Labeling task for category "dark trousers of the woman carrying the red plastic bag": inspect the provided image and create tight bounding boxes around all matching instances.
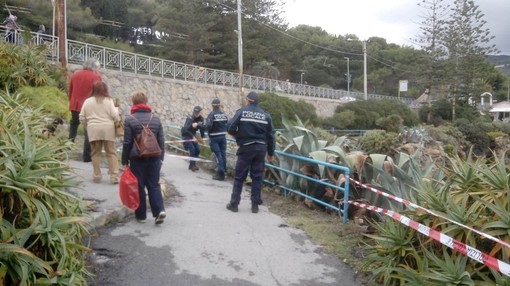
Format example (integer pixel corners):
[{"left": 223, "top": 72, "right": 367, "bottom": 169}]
[{"left": 129, "top": 158, "right": 165, "bottom": 219}]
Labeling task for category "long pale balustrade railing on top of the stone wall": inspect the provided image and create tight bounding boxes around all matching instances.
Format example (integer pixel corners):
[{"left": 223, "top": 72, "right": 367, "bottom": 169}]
[{"left": 0, "top": 26, "right": 414, "bottom": 104}]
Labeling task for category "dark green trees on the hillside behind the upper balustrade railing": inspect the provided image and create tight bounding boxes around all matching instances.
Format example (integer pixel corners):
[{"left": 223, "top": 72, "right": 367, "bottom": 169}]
[{"left": 0, "top": 0, "right": 508, "bottom": 99}]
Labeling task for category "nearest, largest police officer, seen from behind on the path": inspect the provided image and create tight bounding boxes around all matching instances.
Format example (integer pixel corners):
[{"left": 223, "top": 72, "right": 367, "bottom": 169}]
[{"left": 227, "top": 91, "right": 275, "bottom": 213}]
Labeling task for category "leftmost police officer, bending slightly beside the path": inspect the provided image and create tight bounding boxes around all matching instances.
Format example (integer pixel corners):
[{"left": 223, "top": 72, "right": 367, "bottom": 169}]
[{"left": 181, "top": 105, "right": 205, "bottom": 172}]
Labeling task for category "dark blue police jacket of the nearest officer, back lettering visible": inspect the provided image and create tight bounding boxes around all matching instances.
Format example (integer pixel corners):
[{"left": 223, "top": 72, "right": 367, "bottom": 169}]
[{"left": 227, "top": 104, "right": 275, "bottom": 156}]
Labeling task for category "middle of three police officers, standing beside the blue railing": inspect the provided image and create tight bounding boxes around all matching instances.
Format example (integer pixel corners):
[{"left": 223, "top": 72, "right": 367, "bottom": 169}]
[{"left": 205, "top": 98, "right": 228, "bottom": 181}]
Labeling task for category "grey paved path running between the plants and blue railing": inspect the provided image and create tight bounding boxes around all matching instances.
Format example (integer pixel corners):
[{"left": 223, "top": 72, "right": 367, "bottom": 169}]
[{"left": 71, "top": 153, "right": 359, "bottom": 286}]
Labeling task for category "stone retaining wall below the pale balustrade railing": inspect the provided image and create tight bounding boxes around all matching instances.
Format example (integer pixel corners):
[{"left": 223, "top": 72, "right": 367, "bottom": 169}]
[{"left": 70, "top": 65, "right": 341, "bottom": 126}]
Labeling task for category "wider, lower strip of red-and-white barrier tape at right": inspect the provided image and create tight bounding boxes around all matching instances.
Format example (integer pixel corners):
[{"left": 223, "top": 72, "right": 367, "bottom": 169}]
[{"left": 348, "top": 201, "right": 510, "bottom": 277}]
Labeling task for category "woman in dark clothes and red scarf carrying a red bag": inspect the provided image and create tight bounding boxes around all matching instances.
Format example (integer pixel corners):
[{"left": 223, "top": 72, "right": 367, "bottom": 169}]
[{"left": 122, "top": 91, "right": 166, "bottom": 224}]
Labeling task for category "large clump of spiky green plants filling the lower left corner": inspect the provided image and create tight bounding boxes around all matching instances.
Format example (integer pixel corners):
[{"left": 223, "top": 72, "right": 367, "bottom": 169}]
[{"left": 0, "top": 93, "right": 90, "bottom": 285}]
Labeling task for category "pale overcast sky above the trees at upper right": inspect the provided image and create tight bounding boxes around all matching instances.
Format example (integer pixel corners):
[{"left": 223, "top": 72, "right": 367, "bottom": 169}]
[{"left": 284, "top": 0, "right": 510, "bottom": 55}]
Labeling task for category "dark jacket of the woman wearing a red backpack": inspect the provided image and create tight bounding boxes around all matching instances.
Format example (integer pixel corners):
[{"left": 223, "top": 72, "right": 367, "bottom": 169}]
[{"left": 122, "top": 109, "right": 165, "bottom": 165}]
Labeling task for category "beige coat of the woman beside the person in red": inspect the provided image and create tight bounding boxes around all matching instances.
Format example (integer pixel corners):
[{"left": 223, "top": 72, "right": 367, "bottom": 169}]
[{"left": 80, "top": 96, "right": 120, "bottom": 142}]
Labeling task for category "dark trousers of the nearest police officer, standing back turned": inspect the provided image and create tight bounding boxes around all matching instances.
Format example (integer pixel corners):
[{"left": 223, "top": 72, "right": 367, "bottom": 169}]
[{"left": 230, "top": 150, "right": 266, "bottom": 206}]
